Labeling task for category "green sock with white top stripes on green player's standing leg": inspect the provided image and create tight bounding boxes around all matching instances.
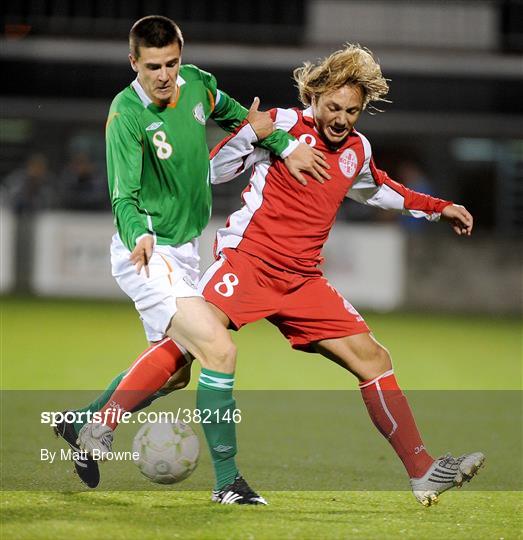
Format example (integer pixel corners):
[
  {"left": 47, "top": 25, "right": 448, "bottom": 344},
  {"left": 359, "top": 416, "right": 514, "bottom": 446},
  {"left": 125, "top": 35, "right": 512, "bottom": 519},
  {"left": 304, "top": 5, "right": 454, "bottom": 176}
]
[{"left": 196, "top": 368, "right": 238, "bottom": 490}]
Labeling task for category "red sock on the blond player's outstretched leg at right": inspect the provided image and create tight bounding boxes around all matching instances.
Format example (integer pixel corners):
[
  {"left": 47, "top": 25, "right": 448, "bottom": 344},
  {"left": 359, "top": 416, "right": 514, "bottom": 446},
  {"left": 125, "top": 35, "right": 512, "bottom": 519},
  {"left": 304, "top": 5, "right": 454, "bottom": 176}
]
[{"left": 360, "top": 370, "right": 434, "bottom": 478}]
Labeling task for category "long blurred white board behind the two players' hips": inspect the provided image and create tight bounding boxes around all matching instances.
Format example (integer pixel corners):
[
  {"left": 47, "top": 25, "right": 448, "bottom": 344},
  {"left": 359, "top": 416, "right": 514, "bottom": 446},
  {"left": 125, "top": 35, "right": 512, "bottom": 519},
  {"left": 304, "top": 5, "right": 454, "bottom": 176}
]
[{"left": 27, "top": 212, "right": 405, "bottom": 310}]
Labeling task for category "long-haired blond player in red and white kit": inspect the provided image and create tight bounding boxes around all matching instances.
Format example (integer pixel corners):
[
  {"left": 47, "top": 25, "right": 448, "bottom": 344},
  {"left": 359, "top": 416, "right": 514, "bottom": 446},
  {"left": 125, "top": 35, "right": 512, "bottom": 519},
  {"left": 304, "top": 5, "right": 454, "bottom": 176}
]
[{"left": 71, "top": 45, "right": 484, "bottom": 506}]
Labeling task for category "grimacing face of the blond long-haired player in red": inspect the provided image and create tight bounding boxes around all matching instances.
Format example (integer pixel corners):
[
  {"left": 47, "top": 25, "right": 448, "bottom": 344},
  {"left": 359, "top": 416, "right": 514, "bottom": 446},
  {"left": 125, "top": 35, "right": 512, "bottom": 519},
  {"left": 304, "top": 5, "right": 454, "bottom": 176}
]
[{"left": 312, "top": 85, "right": 363, "bottom": 147}]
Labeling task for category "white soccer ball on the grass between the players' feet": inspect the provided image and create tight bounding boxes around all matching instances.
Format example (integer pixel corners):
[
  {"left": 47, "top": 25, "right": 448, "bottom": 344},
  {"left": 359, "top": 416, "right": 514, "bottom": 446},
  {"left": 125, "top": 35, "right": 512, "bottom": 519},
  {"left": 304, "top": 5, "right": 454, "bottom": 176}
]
[{"left": 133, "top": 422, "right": 200, "bottom": 484}]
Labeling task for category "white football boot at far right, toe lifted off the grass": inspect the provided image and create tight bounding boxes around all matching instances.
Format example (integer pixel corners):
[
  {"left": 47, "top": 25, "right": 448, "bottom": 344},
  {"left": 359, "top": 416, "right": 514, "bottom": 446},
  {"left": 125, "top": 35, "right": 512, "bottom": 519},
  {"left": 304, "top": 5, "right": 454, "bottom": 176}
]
[{"left": 410, "top": 452, "right": 485, "bottom": 506}]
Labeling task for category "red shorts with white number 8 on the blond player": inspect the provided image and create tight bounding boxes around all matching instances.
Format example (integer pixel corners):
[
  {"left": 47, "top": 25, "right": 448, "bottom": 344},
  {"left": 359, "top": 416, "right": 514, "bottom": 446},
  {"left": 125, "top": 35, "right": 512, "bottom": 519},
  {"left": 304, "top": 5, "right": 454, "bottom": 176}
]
[{"left": 200, "top": 249, "right": 370, "bottom": 352}]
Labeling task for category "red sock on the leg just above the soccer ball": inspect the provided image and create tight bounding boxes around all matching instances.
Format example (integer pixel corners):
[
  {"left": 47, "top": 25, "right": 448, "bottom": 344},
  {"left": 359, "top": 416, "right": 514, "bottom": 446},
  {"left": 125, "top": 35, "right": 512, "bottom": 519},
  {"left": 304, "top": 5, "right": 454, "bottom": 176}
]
[{"left": 100, "top": 338, "right": 187, "bottom": 429}]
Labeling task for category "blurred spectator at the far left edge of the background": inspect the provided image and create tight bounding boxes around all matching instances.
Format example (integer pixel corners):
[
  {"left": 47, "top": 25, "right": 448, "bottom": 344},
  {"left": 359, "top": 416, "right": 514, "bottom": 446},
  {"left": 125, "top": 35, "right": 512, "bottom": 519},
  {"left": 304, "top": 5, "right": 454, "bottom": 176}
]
[{"left": 2, "top": 153, "right": 57, "bottom": 214}]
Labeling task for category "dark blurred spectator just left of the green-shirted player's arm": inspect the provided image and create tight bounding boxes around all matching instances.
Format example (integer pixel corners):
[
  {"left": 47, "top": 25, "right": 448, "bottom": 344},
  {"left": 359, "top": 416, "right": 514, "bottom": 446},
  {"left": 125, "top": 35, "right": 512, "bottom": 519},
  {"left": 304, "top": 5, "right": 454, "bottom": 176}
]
[{"left": 60, "top": 152, "right": 109, "bottom": 210}]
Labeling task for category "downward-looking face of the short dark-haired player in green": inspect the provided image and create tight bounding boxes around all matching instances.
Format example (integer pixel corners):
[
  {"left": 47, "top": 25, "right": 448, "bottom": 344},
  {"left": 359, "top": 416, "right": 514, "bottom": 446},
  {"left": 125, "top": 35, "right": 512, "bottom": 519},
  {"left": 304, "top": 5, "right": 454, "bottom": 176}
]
[{"left": 129, "top": 42, "right": 181, "bottom": 105}]
